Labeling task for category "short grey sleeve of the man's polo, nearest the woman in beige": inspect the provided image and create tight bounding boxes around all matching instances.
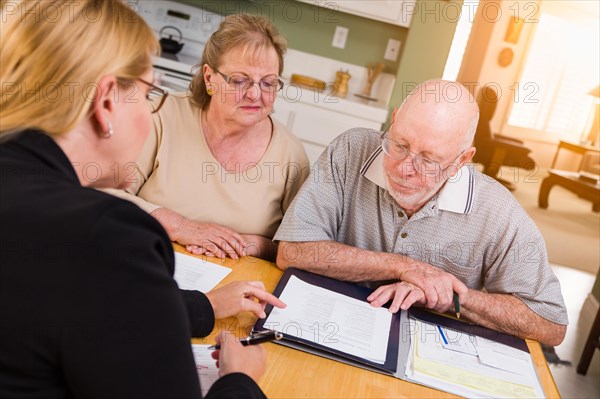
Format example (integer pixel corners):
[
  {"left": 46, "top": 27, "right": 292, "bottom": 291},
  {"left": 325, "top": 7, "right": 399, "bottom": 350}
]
[{"left": 274, "top": 134, "right": 349, "bottom": 242}]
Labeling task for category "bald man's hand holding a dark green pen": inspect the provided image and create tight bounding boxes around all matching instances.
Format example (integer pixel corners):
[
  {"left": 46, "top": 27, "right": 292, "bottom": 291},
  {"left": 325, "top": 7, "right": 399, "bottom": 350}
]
[{"left": 400, "top": 259, "right": 469, "bottom": 313}]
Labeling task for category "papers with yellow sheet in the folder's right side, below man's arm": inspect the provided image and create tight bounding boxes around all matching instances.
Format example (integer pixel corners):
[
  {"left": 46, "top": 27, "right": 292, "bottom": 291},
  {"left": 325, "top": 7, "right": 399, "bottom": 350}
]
[{"left": 405, "top": 319, "right": 545, "bottom": 399}]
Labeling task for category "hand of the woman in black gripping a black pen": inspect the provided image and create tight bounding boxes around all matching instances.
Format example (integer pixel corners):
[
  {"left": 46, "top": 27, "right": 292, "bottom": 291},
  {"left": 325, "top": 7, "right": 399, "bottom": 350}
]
[{"left": 211, "top": 331, "right": 266, "bottom": 382}]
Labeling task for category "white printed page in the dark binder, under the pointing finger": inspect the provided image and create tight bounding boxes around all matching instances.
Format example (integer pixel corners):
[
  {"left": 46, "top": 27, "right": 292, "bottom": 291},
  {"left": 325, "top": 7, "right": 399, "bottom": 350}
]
[{"left": 264, "top": 276, "right": 392, "bottom": 364}]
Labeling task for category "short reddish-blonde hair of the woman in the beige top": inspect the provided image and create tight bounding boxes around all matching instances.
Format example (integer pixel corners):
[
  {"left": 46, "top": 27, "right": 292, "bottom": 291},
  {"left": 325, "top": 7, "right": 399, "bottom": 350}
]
[{"left": 190, "top": 14, "right": 287, "bottom": 109}]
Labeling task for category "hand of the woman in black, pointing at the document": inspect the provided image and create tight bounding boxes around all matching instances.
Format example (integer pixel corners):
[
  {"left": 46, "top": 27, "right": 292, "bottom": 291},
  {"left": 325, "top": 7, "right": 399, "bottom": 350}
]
[{"left": 206, "top": 281, "right": 286, "bottom": 319}]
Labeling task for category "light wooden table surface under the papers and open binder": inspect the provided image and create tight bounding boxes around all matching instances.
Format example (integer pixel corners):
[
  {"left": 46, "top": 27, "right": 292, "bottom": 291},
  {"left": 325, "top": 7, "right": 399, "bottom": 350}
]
[{"left": 174, "top": 244, "right": 560, "bottom": 399}]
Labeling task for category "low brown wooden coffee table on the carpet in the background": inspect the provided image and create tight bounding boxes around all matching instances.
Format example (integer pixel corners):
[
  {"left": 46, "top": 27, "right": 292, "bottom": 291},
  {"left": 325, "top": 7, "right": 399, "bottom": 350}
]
[{"left": 538, "top": 169, "right": 600, "bottom": 212}]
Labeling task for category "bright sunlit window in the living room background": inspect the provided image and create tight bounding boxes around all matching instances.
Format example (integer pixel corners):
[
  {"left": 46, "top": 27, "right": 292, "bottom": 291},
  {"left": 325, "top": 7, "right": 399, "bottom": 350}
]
[{"left": 507, "top": 2, "right": 600, "bottom": 141}]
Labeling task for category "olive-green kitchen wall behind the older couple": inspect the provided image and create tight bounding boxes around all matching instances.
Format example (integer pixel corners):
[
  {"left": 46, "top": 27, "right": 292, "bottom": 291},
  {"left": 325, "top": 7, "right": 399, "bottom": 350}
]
[{"left": 172, "top": 0, "right": 463, "bottom": 119}]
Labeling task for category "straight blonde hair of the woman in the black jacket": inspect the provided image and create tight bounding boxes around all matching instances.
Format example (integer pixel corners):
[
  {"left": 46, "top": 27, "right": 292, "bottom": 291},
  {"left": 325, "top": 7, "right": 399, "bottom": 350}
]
[{"left": 0, "top": 0, "right": 159, "bottom": 138}]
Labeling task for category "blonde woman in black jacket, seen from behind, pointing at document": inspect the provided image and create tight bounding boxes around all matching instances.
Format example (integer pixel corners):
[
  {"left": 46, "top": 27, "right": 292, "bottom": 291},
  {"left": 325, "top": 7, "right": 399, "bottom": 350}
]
[{"left": 0, "top": 0, "right": 282, "bottom": 399}]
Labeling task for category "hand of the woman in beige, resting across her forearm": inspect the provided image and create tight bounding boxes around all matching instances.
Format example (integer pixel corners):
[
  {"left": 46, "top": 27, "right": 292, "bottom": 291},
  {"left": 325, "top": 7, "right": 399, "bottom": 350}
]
[{"left": 171, "top": 219, "right": 248, "bottom": 259}]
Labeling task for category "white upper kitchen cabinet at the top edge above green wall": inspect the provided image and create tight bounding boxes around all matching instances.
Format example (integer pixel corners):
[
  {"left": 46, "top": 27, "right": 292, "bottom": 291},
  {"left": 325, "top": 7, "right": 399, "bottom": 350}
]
[{"left": 298, "top": 0, "right": 416, "bottom": 28}]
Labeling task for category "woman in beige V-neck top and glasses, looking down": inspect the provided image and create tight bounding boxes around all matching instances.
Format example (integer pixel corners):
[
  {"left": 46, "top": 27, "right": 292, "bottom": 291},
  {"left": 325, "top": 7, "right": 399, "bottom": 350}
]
[{"left": 110, "top": 15, "right": 308, "bottom": 259}]
